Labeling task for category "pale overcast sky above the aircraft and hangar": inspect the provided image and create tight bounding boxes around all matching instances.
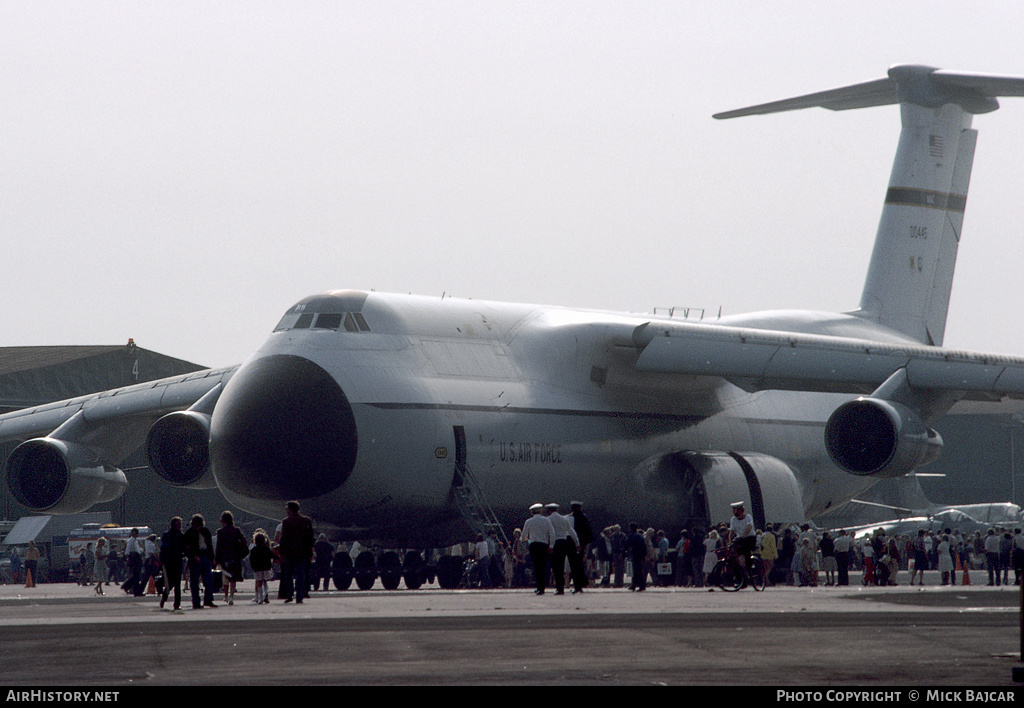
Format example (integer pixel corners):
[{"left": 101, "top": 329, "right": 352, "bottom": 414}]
[{"left": 0, "top": 0, "right": 1024, "bottom": 366}]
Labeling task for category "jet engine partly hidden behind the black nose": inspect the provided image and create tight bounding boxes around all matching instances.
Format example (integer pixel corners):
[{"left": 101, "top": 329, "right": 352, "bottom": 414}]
[{"left": 145, "top": 411, "right": 217, "bottom": 489}]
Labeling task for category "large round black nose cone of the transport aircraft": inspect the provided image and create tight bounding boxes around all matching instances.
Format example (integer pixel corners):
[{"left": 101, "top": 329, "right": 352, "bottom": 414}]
[{"left": 210, "top": 355, "right": 356, "bottom": 500}]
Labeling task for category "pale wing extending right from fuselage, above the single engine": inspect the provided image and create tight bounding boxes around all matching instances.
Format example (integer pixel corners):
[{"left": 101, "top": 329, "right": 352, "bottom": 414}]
[{"left": 633, "top": 323, "right": 1024, "bottom": 401}]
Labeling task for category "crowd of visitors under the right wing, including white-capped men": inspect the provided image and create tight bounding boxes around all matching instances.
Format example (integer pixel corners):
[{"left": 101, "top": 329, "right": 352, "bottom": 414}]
[{"left": 482, "top": 502, "right": 1024, "bottom": 593}]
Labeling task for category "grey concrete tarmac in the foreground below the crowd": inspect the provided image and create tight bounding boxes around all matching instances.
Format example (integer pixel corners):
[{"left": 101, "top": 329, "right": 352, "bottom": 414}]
[{"left": 0, "top": 574, "right": 1021, "bottom": 691}]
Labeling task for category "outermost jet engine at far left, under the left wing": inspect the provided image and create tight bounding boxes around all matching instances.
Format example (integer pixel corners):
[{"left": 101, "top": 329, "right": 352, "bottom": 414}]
[{"left": 7, "top": 438, "right": 128, "bottom": 513}]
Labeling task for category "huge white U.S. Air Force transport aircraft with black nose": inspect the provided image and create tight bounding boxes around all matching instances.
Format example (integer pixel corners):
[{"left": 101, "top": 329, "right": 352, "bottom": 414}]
[{"left": 0, "top": 66, "right": 1024, "bottom": 586}]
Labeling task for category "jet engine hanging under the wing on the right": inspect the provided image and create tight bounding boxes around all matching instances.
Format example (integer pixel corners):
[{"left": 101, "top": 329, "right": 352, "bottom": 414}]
[{"left": 825, "top": 398, "right": 942, "bottom": 477}]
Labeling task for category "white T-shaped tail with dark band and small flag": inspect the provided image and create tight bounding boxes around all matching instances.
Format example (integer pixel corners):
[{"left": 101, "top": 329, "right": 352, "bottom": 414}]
[{"left": 715, "top": 65, "right": 1024, "bottom": 345}]
